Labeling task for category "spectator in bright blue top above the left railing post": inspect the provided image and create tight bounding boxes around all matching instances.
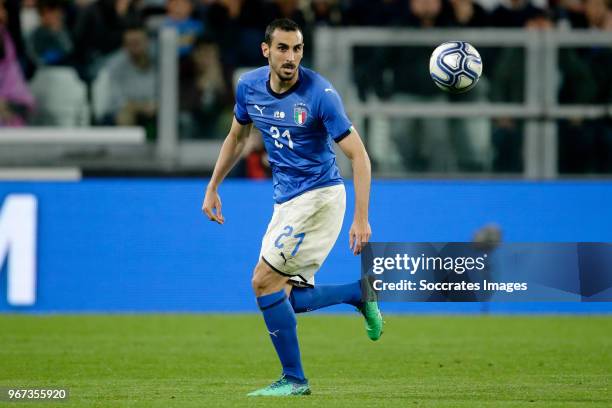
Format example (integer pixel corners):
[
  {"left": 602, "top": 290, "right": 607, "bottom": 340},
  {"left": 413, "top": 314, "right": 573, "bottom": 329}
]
[{"left": 162, "top": 0, "right": 204, "bottom": 58}]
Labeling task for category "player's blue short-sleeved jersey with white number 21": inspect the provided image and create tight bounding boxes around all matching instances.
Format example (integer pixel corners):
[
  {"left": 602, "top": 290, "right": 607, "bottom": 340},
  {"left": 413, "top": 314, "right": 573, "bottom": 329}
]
[{"left": 234, "top": 66, "right": 351, "bottom": 203}]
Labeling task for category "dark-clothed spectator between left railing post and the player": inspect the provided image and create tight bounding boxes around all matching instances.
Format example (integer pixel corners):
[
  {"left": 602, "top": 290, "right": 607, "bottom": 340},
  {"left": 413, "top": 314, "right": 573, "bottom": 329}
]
[{"left": 180, "top": 39, "right": 231, "bottom": 139}]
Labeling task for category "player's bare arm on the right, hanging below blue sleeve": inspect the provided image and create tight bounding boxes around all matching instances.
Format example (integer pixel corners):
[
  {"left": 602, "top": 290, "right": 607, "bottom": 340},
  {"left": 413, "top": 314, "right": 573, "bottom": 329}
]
[{"left": 338, "top": 128, "right": 372, "bottom": 255}]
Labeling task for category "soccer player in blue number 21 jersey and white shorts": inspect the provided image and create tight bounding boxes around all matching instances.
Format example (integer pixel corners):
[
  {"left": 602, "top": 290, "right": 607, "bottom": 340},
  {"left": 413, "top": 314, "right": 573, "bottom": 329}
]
[{"left": 202, "top": 19, "right": 383, "bottom": 396}]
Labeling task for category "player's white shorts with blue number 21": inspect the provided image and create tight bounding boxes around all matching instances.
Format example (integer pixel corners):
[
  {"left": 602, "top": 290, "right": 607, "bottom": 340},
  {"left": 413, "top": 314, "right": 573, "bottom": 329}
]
[{"left": 259, "top": 184, "right": 346, "bottom": 286}]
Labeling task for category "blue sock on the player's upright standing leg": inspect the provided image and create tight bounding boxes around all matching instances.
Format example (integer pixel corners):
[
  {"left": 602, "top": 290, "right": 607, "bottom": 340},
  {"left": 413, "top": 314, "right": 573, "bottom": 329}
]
[{"left": 257, "top": 290, "right": 305, "bottom": 381}]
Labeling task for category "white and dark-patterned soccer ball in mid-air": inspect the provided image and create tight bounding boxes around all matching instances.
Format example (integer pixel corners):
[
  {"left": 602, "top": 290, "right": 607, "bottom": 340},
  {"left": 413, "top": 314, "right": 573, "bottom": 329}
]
[{"left": 429, "top": 41, "right": 482, "bottom": 93}]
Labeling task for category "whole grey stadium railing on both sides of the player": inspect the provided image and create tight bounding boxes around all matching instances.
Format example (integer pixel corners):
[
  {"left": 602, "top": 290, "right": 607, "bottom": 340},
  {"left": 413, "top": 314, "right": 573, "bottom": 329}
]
[{"left": 0, "top": 27, "right": 612, "bottom": 179}]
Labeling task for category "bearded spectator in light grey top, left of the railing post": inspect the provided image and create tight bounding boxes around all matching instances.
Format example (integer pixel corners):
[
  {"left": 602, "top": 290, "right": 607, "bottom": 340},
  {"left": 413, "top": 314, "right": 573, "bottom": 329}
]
[{"left": 109, "top": 25, "right": 157, "bottom": 140}]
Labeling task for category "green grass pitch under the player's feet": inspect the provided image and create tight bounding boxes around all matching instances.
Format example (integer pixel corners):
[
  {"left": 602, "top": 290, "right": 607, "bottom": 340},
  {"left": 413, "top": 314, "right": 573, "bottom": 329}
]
[{"left": 0, "top": 315, "right": 612, "bottom": 408}]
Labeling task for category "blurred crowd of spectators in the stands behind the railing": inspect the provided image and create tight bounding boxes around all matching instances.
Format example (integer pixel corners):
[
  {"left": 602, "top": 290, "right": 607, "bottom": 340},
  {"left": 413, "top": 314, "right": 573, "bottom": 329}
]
[{"left": 0, "top": 0, "right": 612, "bottom": 174}]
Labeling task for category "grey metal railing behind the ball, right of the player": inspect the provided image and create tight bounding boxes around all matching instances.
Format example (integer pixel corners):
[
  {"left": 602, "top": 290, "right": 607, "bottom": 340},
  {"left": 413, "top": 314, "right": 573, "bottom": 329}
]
[{"left": 314, "top": 27, "right": 612, "bottom": 179}]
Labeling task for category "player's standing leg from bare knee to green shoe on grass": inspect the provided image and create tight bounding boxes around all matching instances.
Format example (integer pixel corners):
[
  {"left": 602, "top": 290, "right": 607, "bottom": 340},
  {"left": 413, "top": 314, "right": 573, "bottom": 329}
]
[{"left": 248, "top": 260, "right": 310, "bottom": 396}]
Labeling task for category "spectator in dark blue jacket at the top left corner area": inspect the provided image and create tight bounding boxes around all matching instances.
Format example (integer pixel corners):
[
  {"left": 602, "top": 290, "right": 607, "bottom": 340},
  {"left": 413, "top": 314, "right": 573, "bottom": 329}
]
[{"left": 28, "top": 0, "right": 72, "bottom": 66}]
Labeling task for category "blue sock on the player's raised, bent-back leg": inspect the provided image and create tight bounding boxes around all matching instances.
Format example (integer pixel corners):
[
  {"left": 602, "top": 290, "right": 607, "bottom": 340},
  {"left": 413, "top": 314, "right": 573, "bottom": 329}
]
[{"left": 289, "top": 281, "right": 361, "bottom": 313}]
